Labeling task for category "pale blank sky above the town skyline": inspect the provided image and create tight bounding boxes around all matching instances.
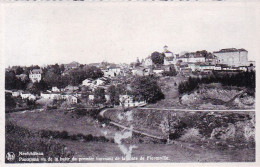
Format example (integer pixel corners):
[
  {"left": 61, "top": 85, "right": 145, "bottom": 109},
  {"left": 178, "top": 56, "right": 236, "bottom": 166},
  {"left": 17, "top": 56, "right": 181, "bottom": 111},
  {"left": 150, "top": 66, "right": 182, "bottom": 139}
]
[{"left": 2, "top": 2, "right": 260, "bottom": 67}]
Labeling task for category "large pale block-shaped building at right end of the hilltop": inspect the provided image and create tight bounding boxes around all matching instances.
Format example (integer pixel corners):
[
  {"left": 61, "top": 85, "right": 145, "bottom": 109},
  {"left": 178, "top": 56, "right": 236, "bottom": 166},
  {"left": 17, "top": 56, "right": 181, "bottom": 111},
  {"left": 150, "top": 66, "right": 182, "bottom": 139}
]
[{"left": 213, "top": 48, "right": 250, "bottom": 67}]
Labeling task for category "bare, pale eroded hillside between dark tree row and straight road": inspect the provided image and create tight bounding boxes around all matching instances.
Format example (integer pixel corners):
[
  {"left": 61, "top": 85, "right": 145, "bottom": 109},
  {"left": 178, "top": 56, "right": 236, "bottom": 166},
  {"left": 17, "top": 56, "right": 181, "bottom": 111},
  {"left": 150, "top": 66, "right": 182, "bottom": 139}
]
[{"left": 147, "top": 75, "right": 255, "bottom": 110}]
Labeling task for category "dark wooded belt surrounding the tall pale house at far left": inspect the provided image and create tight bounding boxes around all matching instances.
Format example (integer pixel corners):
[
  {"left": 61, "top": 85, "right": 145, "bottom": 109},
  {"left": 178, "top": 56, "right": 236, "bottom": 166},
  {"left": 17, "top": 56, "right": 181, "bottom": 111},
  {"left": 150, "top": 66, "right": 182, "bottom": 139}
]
[{"left": 5, "top": 64, "right": 104, "bottom": 94}]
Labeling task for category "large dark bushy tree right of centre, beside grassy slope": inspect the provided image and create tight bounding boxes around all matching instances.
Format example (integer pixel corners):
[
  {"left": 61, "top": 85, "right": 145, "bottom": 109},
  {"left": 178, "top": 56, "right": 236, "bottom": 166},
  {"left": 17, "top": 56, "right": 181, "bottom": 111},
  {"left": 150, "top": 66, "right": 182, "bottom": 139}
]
[{"left": 131, "top": 76, "right": 164, "bottom": 103}]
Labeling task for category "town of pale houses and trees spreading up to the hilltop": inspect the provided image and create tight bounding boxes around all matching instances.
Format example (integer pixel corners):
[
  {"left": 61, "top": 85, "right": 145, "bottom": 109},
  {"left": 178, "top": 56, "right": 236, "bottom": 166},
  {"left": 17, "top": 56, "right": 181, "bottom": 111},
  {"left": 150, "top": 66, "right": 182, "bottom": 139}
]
[{"left": 6, "top": 46, "right": 255, "bottom": 109}]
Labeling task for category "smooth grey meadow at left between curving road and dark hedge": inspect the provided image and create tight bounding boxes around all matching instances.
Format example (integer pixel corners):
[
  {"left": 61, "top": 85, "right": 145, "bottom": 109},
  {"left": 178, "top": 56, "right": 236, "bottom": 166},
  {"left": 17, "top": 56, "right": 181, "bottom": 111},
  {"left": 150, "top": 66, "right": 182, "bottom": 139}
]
[{"left": 6, "top": 110, "right": 118, "bottom": 138}]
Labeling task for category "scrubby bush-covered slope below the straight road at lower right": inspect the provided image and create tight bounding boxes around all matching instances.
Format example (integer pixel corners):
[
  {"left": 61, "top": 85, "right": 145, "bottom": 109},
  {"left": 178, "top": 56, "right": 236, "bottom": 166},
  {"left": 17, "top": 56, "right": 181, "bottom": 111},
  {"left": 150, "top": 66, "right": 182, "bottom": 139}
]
[{"left": 169, "top": 112, "right": 255, "bottom": 144}]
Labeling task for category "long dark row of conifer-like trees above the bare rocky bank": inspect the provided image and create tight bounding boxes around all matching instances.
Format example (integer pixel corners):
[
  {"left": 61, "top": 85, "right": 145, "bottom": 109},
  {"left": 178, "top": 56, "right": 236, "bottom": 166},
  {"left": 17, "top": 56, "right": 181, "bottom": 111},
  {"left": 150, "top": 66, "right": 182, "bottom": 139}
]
[{"left": 178, "top": 71, "right": 256, "bottom": 94}]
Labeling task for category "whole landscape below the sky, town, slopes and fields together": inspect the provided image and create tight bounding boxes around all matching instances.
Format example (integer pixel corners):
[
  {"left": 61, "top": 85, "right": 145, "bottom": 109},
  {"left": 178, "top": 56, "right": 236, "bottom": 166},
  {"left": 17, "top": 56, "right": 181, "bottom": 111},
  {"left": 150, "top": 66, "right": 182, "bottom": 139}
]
[{"left": 5, "top": 46, "right": 255, "bottom": 162}]
